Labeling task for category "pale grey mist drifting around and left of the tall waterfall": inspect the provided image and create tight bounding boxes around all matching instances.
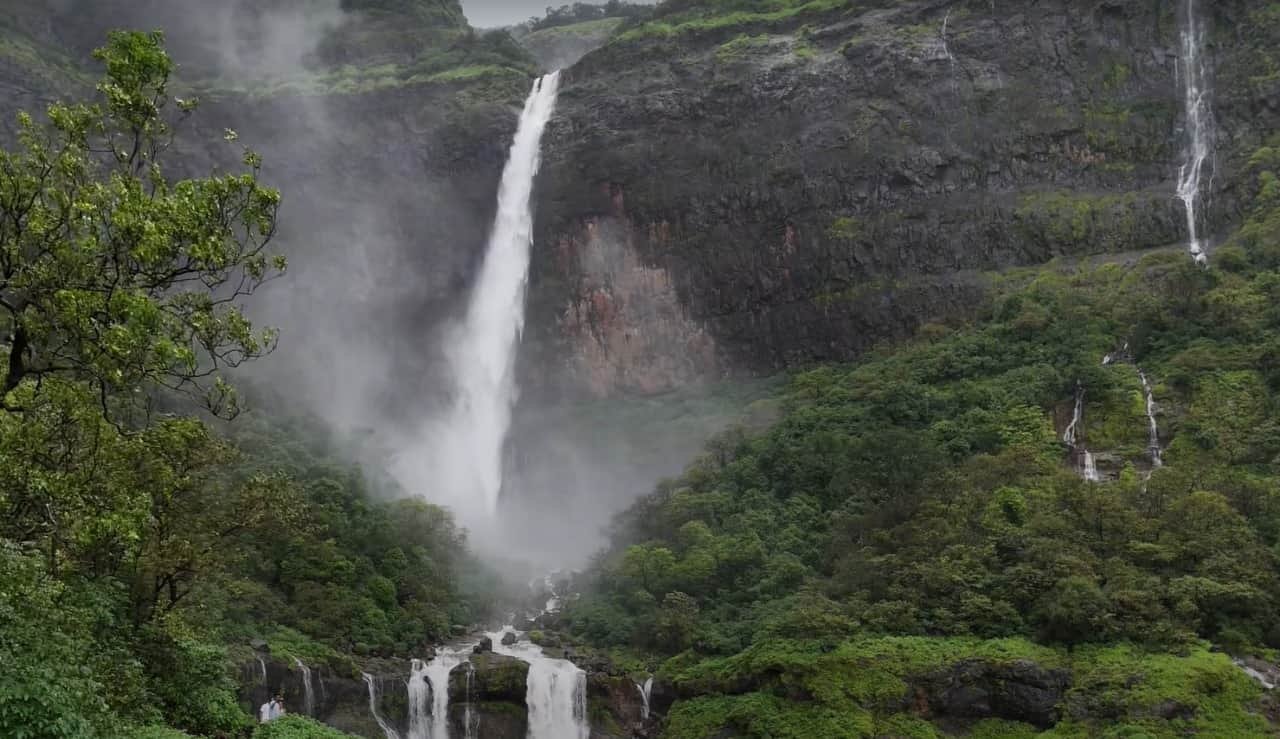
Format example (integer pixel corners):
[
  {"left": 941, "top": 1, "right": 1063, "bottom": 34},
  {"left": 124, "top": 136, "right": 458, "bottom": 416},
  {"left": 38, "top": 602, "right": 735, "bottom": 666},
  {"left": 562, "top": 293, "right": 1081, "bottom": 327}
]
[{"left": 40, "top": 0, "right": 722, "bottom": 569}]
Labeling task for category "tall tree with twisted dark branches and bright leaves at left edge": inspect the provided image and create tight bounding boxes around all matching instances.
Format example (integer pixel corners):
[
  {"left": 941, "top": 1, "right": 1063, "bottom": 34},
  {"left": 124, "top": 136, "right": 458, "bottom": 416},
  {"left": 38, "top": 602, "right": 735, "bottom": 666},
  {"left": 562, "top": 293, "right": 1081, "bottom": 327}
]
[{"left": 0, "top": 32, "right": 284, "bottom": 416}]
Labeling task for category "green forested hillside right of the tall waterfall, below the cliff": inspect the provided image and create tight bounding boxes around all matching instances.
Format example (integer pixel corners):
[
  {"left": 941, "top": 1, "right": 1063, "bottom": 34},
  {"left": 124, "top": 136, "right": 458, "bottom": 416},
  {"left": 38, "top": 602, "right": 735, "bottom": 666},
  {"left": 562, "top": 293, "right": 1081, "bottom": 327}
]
[{"left": 566, "top": 142, "right": 1280, "bottom": 738}]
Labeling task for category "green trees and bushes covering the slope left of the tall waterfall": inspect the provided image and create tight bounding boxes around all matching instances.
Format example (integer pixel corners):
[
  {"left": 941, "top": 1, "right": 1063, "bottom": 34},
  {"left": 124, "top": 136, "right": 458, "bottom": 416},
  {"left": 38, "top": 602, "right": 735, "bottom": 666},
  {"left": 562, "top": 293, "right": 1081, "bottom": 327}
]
[{"left": 0, "top": 32, "right": 497, "bottom": 739}]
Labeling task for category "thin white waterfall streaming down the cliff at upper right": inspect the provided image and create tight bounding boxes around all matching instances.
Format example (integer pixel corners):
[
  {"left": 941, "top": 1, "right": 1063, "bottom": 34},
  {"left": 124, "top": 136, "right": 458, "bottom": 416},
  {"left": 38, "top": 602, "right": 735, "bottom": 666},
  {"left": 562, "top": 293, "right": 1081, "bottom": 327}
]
[{"left": 1178, "top": 0, "right": 1213, "bottom": 264}]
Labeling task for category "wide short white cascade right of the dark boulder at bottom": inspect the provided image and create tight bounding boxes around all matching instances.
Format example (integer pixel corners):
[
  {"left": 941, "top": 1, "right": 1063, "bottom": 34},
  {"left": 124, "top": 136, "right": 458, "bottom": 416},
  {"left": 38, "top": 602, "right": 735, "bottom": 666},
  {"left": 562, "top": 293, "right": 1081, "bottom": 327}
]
[{"left": 489, "top": 628, "right": 591, "bottom": 739}]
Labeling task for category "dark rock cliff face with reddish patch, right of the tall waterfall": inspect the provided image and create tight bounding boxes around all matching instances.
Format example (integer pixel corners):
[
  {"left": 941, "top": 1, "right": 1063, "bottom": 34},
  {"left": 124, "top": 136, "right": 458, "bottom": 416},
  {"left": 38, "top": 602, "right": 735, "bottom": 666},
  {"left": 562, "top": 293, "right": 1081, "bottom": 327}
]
[{"left": 527, "top": 0, "right": 1280, "bottom": 394}]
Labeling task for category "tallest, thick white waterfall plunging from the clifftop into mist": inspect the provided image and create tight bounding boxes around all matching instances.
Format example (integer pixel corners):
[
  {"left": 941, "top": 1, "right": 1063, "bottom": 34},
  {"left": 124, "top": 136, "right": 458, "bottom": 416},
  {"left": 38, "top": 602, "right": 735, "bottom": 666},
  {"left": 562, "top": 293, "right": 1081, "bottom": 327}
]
[{"left": 434, "top": 72, "right": 559, "bottom": 516}]
